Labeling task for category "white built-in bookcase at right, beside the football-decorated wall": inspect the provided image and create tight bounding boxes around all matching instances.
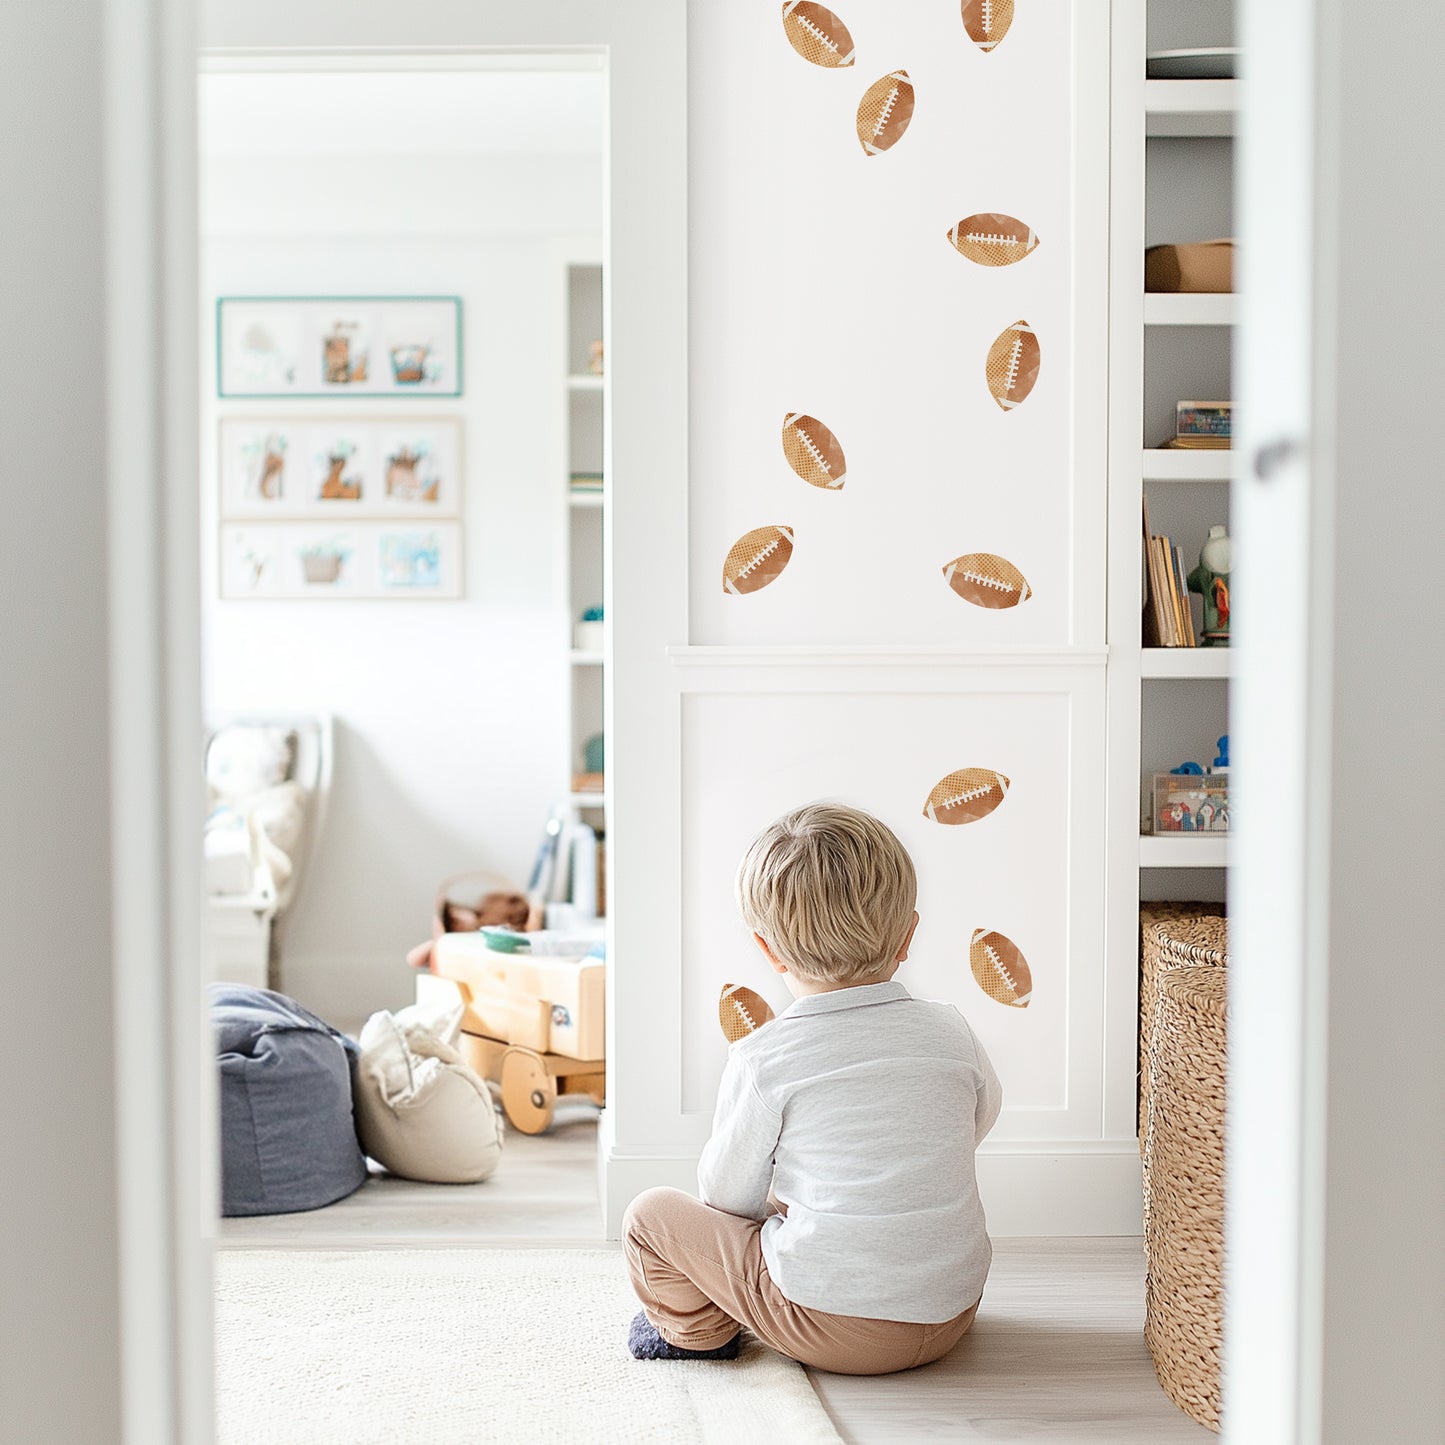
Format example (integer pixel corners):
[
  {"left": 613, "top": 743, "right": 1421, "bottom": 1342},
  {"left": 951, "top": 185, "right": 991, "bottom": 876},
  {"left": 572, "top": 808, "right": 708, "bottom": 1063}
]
[{"left": 1108, "top": 0, "right": 1237, "bottom": 951}]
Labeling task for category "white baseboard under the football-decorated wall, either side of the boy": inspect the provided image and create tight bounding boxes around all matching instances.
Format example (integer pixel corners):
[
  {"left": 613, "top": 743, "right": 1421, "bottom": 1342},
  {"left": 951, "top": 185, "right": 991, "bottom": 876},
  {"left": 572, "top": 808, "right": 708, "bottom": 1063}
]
[{"left": 597, "top": 1111, "right": 1143, "bottom": 1240}]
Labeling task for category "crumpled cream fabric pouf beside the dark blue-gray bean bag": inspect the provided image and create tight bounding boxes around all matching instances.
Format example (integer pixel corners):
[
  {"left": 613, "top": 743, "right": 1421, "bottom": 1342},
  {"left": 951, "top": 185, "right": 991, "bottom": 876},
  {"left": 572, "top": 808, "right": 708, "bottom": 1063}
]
[{"left": 355, "top": 1006, "right": 501, "bottom": 1183}]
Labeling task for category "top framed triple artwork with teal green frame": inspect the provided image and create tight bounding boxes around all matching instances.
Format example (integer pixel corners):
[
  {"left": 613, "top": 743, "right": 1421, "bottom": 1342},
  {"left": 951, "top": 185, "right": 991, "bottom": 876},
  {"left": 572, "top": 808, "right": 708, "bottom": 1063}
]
[{"left": 215, "top": 296, "right": 461, "bottom": 397}]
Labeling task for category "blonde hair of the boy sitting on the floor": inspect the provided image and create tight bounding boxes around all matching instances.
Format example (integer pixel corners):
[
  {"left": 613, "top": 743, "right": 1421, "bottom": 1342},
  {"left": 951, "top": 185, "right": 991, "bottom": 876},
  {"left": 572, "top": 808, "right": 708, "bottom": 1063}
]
[{"left": 737, "top": 803, "right": 918, "bottom": 984}]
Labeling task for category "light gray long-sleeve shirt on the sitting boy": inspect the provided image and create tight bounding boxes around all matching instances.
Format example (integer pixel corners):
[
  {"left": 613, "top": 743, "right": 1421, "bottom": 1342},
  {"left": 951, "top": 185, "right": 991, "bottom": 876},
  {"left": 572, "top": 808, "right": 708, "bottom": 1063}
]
[{"left": 698, "top": 983, "right": 1003, "bottom": 1324}]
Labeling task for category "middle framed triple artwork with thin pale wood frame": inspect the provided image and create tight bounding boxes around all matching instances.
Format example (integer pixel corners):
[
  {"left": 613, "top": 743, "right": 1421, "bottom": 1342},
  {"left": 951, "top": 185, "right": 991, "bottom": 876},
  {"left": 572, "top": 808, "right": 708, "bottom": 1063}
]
[{"left": 217, "top": 416, "right": 461, "bottom": 522}]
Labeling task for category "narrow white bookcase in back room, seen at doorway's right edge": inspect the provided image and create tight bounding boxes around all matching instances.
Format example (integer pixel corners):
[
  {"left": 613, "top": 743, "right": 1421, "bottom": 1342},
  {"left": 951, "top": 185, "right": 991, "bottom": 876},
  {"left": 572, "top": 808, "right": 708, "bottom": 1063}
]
[{"left": 562, "top": 263, "right": 607, "bottom": 855}]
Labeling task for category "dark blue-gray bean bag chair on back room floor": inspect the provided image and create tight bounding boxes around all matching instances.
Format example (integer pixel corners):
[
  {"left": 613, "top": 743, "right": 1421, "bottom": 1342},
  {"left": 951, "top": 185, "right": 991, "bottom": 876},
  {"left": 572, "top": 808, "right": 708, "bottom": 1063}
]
[{"left": 211, "top": 984, "right": 366, "bottom": 1215}]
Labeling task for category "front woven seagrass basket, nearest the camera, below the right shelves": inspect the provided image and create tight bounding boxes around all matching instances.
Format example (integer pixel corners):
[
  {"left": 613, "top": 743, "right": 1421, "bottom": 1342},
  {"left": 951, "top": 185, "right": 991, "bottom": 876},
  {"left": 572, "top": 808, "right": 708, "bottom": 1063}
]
[{"left": 1144, "top": 967, "right": 1227, "bottom": 1431}]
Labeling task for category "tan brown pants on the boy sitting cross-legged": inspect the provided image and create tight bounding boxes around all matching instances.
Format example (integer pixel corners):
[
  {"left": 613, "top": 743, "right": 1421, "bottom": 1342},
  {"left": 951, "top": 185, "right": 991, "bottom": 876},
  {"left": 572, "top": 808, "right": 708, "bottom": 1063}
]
[{"left": 623, "top": 1189, "right": 978, "bottom": 1374}]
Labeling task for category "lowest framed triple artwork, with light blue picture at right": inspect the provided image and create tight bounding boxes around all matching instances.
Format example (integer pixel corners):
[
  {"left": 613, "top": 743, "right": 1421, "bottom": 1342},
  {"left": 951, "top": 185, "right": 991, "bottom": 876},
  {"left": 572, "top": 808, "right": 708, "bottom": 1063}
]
[{"left": 220, "top": 520, "right": 462, "bottom": 601}]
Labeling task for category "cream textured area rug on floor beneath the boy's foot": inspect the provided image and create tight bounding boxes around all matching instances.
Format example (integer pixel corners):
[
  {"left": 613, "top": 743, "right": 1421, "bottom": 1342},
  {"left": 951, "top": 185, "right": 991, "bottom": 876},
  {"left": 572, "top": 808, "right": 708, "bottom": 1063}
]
[{"left": 215, "top": 1250, "right": 840, "bottom": 1445}]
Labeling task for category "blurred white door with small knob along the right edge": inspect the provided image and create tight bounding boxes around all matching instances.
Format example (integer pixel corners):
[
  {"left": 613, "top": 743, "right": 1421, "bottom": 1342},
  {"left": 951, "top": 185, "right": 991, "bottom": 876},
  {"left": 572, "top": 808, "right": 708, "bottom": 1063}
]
[{"left": 1224, "top": 0, "right": 1445, "bottom": 1445}]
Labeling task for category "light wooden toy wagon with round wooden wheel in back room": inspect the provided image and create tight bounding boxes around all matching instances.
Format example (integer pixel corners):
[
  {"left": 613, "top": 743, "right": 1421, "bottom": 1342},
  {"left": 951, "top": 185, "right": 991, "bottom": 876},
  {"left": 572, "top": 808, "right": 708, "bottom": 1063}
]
[{"left": 416, "top": 933, "right": 607, "bottom": 1134}]
